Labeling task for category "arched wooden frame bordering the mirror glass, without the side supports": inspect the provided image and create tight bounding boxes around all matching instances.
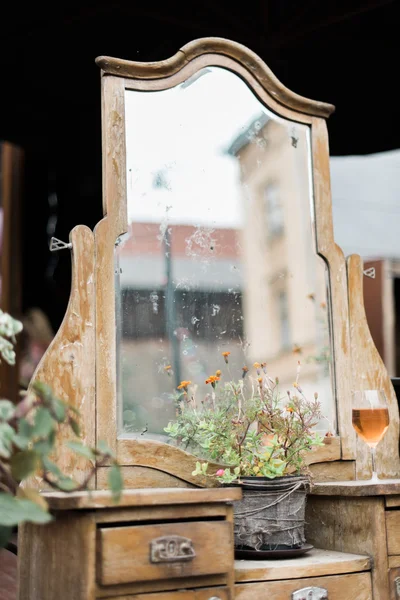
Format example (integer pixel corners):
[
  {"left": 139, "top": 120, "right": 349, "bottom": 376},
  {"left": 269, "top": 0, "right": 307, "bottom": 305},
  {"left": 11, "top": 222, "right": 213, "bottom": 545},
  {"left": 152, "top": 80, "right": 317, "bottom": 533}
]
[{"left": 95, "top": 38, "right": 399, "bottom": 487}]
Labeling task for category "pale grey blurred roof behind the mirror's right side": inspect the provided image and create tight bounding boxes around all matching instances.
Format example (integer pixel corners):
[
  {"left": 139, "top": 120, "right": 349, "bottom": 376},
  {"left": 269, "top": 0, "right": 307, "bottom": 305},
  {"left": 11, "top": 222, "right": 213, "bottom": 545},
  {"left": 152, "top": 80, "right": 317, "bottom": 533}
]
[{"left": 331, "top": 150, "right": 400, "bottom": 259}]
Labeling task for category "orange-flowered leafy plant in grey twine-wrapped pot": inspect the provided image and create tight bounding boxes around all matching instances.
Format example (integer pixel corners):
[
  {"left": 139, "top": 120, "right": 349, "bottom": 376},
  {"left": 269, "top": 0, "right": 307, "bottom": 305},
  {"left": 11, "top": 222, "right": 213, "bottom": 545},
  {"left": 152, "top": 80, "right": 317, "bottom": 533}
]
[{"left": 165, "top": 352, "right": 332, "bottom": 551}]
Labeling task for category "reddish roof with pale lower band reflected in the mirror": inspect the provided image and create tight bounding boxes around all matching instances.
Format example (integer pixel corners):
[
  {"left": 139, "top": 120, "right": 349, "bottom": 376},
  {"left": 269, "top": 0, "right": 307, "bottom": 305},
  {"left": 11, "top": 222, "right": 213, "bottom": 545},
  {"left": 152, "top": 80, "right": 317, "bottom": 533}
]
[{"left": 117, "top": 223, "right": 242, "bottom": 291}]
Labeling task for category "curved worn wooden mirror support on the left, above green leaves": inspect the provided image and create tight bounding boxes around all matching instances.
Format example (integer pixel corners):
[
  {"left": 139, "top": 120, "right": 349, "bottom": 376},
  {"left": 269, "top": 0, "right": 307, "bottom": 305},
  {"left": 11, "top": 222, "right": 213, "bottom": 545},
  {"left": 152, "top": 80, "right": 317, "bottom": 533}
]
[{"left": 27, "top": 225, "right": 95, "bottom": 482}]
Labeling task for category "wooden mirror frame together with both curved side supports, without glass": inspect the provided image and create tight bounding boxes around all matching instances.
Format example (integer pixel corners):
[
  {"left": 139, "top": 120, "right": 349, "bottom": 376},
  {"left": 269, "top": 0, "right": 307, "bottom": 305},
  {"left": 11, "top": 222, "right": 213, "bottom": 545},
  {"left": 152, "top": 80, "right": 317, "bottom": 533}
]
[{"left": 32, "top": 38, "right": 400, "bottom": 487}]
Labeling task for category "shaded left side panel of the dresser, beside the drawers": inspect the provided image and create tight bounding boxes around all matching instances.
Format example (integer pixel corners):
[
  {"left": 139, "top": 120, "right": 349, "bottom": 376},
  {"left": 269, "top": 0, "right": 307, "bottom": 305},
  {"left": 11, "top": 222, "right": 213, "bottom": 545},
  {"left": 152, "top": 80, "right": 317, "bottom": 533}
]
[{"left": 18, "top": 513, "right": 96, "bottom": 600}]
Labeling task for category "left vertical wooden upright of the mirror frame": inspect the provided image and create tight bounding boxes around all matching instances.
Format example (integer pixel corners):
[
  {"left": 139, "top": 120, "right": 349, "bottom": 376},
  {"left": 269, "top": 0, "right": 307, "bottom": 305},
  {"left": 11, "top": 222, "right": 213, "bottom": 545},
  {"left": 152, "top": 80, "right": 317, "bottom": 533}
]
[{"left": 95, "top": 72, "right": 127, "bottom": 458}]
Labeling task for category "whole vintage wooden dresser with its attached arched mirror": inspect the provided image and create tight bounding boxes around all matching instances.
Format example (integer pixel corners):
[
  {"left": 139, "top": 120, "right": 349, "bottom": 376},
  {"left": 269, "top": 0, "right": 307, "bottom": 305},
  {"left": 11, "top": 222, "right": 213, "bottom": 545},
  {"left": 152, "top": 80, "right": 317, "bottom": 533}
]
[{"left": 20, "top": 38, "right": 400, "bottom": 600}]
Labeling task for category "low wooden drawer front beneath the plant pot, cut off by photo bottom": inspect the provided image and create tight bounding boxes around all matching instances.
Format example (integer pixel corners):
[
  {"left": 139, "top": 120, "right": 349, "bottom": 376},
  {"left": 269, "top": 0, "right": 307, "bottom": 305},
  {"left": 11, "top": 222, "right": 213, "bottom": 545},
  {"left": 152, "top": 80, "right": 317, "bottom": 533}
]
[{"left": 235, "top": 565, "right": 372, "bottom": 600}]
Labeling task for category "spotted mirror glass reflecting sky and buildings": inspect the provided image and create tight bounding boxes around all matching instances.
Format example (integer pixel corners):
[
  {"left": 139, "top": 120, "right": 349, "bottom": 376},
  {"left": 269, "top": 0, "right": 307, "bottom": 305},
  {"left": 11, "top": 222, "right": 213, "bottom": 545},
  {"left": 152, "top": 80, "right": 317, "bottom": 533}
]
[{"left": 115, "top": 67, "right": 336, "bottom": 441}]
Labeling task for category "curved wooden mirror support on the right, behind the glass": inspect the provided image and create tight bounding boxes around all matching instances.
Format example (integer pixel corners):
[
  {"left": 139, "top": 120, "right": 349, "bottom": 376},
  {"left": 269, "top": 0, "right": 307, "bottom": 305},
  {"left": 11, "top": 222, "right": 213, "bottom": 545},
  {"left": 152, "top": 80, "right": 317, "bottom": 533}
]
[{"left": 347, "top": 254, "right": 400, "bottom": 479}]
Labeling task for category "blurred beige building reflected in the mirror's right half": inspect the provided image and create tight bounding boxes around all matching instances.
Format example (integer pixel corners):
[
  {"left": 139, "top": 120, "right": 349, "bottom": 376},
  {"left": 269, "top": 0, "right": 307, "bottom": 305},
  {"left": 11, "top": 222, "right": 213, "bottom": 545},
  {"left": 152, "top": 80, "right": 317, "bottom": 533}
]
[{"left": 229, "top": 115, "right": 333, "bottom": 426}]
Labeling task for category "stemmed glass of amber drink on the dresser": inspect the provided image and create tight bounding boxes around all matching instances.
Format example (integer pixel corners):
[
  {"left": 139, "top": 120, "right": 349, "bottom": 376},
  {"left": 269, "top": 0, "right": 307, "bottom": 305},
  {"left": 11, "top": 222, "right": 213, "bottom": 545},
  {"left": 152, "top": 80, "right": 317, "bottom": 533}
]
[{"left": 352, "top": 390, "right": 389, "bottom": 481}]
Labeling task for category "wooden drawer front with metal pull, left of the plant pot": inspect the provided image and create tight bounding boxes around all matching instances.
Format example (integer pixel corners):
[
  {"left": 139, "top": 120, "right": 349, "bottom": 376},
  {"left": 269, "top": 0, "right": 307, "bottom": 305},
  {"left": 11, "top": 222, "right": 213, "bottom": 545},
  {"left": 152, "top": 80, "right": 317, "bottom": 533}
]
[{"left": 97, "top": 521, "right": 233, "bottom": 585}]
